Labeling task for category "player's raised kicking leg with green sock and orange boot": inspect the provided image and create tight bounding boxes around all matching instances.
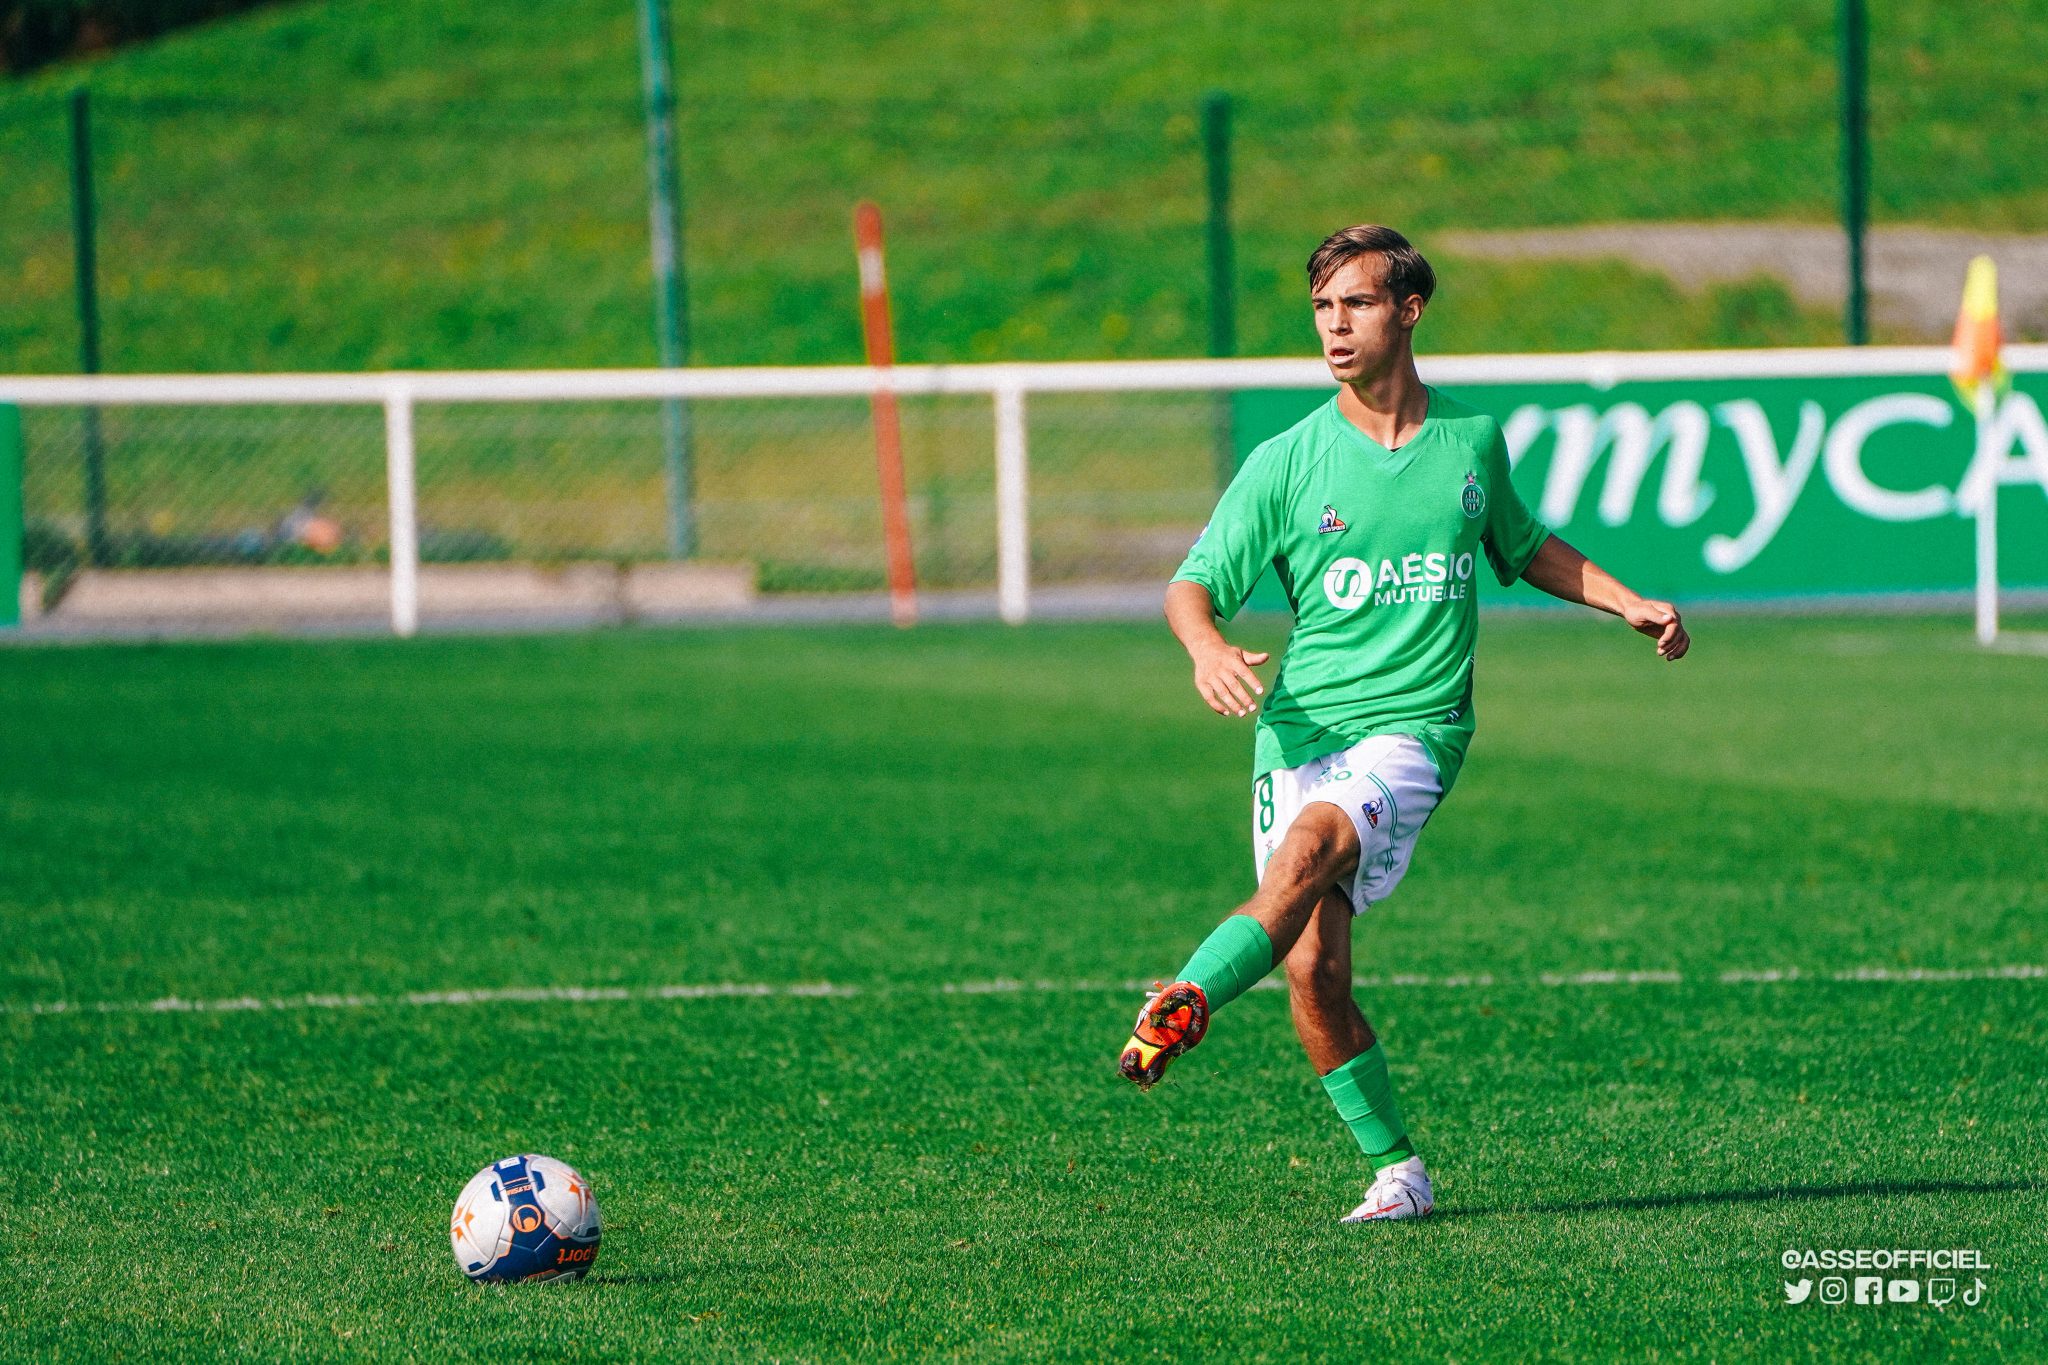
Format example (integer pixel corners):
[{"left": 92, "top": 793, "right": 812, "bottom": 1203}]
[{"left": 1118, "top": 800, "right": 1358, "bottom": 1089}]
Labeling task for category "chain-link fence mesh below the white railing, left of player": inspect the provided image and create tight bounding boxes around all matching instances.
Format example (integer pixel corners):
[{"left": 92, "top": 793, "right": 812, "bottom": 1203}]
[{"left": 23, "top": 384, "right": 1217, "bottom": 608}]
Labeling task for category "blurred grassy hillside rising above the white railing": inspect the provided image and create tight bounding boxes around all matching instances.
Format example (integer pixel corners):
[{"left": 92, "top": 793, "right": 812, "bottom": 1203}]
[{"left": 0, "top": 0, "right": 2048, "bottom": 372}]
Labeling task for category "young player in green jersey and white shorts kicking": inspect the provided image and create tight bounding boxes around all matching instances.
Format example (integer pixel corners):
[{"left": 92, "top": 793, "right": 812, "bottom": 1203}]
[{"left": 1120, "top": 225, "right": 1690, "bottom": 1222}]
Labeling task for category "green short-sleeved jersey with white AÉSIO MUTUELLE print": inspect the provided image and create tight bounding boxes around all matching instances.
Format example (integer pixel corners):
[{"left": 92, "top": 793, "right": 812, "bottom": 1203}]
[{"left": 1174, "top": 389, "right": 1548, "bottom": 792}]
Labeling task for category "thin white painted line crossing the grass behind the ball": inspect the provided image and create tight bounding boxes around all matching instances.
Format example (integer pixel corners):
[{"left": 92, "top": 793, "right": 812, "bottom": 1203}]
[{"left": 0, "top": 964, "right": 2048, "bottom": 1015}]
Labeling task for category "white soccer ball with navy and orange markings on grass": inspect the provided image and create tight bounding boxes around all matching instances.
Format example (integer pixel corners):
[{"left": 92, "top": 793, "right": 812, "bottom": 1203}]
[{"left": 449, "top": 1156, "right": 600, "bottom": 1283}]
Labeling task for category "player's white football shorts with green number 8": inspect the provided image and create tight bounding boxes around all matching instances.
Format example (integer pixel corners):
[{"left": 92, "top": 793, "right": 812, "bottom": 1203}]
[{"left": 1251, "top": 735, "right": 1444, "bottom": 915}]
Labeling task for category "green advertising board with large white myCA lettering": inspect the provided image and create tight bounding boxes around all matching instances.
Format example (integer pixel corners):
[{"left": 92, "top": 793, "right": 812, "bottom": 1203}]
[{"left": 1235, "top": 375, "right": 2048, "bottom": 610}]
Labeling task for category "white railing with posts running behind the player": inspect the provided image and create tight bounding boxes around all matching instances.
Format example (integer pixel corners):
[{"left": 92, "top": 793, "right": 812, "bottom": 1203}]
[{"left": 0, "top": 346, "right": 2048, "bottom": 634}]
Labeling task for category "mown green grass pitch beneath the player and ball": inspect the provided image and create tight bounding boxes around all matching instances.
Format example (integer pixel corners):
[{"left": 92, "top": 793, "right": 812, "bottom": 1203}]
[{"left": 0, "top": 618, "right": 2048, "bottom": 1361}]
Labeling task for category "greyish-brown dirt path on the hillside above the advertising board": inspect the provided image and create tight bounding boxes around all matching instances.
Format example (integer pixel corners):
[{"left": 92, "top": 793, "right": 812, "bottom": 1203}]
[{"left": 1434, "top": 223, "right": 2048, "bottom": 342}]
